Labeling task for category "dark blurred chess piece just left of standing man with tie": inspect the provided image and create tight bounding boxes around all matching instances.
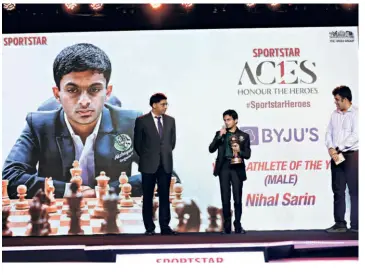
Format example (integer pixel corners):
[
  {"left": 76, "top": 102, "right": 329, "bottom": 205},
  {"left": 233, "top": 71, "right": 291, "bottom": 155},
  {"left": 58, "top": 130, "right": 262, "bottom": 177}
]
[{"left": 101, "top": 188, "right": 120, "bottom": 234}]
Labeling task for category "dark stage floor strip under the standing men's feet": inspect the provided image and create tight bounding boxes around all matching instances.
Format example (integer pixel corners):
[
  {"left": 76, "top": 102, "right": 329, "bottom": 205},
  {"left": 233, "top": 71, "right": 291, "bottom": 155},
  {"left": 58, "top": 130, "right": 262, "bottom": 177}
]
[{"left": 2, "top": 230, "right": 358, "bottom": 249}]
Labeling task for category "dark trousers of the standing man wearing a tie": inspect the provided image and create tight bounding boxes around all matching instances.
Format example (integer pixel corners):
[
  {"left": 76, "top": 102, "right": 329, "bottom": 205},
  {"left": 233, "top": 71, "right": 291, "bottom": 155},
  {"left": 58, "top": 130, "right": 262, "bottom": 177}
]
[{"left": 142, "top": 165, "right": 171, "bottom": 231}]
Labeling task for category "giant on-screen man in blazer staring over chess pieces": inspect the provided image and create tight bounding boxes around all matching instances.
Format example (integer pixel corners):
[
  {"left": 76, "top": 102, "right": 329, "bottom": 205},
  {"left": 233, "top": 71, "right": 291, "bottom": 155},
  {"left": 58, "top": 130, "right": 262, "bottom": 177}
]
[{"left": 2, "top": 43, "right": 180, "bottom": 198}]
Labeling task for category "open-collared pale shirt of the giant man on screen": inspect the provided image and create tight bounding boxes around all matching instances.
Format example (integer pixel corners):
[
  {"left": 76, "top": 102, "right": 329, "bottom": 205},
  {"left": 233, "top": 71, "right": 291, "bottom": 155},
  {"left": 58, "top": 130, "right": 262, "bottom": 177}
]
[{"left": 64, "top": 113, "right": 101, "bottom": 195}]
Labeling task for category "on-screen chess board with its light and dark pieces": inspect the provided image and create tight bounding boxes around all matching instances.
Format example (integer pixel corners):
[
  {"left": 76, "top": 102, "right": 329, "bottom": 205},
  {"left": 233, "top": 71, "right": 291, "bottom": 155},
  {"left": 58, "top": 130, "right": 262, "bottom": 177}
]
[{"left": 2, "top": 161, "right": 222, "bottom": 236}]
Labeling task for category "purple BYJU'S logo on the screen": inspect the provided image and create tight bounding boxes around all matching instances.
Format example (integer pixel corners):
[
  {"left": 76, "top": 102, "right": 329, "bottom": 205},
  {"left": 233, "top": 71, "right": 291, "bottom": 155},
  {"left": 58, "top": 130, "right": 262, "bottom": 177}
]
[{"left": 240, "top": 127, "right": 319, "bottom": 145}]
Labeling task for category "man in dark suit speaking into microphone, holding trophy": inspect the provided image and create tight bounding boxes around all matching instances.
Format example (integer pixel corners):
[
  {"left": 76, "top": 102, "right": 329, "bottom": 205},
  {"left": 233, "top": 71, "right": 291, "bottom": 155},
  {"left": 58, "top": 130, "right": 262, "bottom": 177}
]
[{"left": 209, "top": 109, "right": 251, "bottom": 234}]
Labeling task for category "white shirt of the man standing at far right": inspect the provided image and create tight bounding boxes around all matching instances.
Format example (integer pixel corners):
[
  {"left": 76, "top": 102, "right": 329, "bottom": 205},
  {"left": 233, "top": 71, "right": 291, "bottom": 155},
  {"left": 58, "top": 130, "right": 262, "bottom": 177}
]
[{"left": 326, "top": 105, "right": 359, "bottom": 152}]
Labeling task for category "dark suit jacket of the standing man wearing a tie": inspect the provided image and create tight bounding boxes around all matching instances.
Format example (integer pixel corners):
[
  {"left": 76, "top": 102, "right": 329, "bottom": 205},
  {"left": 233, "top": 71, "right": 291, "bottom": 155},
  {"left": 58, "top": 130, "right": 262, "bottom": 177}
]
[{"left": 134, "top": 112, "right": 176, "bottom": 173}]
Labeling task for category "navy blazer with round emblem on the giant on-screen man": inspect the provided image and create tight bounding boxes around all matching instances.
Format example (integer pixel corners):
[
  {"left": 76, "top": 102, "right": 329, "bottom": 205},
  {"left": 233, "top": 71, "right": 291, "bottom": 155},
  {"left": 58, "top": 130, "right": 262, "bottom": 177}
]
[{"left": 2, "top": 104, "right": 142, "bottom": 198}]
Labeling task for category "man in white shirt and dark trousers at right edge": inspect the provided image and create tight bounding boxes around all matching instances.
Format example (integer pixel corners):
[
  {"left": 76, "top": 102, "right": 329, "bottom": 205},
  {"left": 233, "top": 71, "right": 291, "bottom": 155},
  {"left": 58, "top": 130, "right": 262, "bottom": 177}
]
[{"left": 326, "top": 86, "right": 359, "bottom": 232}]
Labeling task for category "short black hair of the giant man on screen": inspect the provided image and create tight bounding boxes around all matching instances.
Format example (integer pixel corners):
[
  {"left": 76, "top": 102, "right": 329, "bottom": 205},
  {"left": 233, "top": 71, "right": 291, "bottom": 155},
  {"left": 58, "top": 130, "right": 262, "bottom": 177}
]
[{"left": 53, "top": 43, "right": 112, "bottom": 88}]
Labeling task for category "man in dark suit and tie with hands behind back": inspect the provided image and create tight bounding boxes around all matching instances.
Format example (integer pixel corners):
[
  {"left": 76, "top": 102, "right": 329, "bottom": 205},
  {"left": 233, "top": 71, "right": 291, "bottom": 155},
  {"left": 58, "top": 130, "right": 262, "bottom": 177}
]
[{"left": 134, "top": 93, "right": 176, "bottom": 235}]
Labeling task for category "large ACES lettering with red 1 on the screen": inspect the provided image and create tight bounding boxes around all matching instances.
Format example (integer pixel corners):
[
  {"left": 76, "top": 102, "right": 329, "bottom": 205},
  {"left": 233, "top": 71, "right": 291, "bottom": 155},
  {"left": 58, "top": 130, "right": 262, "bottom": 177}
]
[{"left": 238, "top": 59, "right": 317, "bottom": 85}]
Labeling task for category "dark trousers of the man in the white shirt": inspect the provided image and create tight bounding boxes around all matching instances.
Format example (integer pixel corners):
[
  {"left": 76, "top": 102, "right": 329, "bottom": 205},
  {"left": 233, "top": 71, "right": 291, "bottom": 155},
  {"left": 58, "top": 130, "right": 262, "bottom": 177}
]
[{"left": 331, "top": 151, "right": 359, "bottom": 229}]
